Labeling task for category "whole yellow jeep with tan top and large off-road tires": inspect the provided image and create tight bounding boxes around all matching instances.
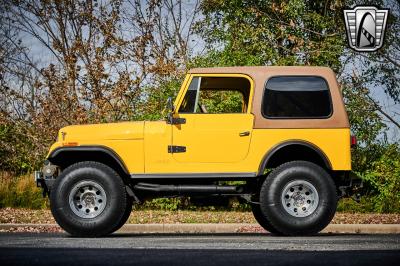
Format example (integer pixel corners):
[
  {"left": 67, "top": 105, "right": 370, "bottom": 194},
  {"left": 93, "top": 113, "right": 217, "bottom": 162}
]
[{"left": 35, "top": 67, "right": 355, "bottom": 237}]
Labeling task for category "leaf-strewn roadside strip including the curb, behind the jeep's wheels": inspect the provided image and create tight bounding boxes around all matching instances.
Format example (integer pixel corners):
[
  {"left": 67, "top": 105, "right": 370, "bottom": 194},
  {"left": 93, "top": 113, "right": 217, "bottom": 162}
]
[{"left": 0, "top": 208, "right": 400, "bottom": 233}]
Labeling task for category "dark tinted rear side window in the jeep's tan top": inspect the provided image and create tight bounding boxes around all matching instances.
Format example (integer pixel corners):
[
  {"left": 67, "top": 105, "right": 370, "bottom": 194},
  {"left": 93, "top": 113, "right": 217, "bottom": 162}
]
[{"left": 262, "top": 76, "right": 332, "bottom": 118}]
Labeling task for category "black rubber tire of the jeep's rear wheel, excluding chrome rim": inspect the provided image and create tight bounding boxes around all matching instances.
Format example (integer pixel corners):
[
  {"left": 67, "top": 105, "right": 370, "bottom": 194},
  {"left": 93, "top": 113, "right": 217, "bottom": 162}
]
[{"left": 260, "top": 161, "right": 337, "bottom": 235}]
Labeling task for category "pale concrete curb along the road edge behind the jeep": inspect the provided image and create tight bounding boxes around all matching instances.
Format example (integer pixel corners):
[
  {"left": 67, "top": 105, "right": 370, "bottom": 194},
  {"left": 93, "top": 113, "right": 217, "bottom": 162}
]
[{"left": 0, "top": 223, "right": 400, "bottom": 234}]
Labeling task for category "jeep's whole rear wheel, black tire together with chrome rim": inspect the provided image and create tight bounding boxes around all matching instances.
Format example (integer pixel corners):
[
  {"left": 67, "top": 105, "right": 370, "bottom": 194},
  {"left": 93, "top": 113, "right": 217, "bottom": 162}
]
[{"left": 260, "top": 161, "right": 337, "bottom": 235}]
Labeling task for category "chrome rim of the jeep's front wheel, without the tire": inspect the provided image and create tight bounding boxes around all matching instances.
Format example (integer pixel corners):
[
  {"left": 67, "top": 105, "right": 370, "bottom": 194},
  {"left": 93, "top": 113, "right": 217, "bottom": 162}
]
[{"left": 69, "top": 181, "right": 107, "bottom": 218}]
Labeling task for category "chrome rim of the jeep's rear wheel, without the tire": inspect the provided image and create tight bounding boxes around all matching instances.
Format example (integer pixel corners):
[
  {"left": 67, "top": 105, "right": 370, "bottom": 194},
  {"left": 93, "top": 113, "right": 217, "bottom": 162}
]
[{"left": 281, "top": 180, "right": 319, "bottom": 217}]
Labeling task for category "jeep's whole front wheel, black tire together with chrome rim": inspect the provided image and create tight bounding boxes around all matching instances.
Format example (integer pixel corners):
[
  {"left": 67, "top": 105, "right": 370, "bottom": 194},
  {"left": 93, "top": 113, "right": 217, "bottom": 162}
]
[{"left": 50, "top": 162, "right": 129, "bottom": 237}]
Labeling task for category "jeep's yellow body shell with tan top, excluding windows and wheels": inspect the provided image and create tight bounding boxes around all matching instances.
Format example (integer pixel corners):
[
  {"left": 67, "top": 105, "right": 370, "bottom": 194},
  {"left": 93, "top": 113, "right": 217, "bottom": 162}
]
[{"left": 48, "top": 67, "right": 351, "bottom": 178}]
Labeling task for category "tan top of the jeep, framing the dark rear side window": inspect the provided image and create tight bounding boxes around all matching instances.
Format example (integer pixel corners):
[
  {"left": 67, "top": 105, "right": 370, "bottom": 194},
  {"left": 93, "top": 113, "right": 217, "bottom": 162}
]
[{"left": 189, "top": 66, "right": 349, "bottom": 128}]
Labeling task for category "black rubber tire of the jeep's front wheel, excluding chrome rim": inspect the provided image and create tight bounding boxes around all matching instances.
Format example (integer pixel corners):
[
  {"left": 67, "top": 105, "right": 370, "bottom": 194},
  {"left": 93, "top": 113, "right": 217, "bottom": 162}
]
[{"left": 50, "top": 162, "right": 127, "bottom": 236}]
